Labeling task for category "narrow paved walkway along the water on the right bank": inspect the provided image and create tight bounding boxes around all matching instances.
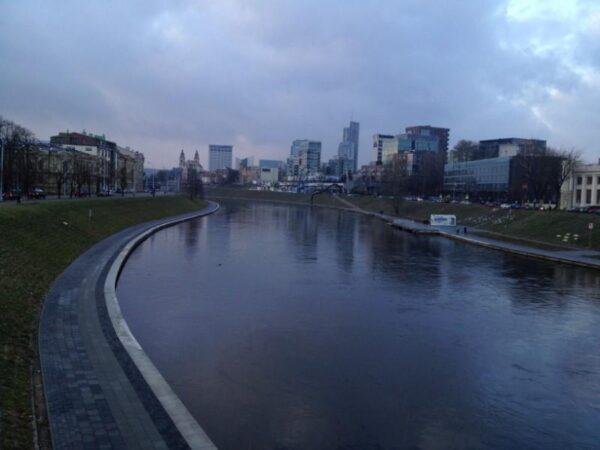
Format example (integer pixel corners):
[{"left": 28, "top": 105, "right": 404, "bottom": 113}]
[{"left": 335, "top": 196, "right": 600, "bottom": 269}]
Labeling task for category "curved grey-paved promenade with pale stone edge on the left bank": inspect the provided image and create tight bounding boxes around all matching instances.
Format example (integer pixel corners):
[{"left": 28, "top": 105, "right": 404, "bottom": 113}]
[{"left": 39, "top": 202, "right": 219, "bottom": 450}]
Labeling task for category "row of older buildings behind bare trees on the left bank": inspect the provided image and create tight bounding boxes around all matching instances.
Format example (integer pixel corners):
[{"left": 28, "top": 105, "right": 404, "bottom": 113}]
[{"left": 0, "top": 125, "right": 144, "bottom": 198}]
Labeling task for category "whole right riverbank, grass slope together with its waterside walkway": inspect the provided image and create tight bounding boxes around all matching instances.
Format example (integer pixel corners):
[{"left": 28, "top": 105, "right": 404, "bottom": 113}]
[{"left": 207, "top": 188, "right": 600, "bottom": 269}]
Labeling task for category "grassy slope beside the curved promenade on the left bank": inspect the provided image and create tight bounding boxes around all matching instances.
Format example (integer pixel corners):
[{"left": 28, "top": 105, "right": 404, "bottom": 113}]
[{"left": 0, "top": 197, "right": 205, "bottom": 448}]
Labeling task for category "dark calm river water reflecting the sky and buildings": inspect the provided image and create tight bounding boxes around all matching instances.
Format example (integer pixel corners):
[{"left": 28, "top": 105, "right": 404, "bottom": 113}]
[{"left": 118, "top": 201, "right": 600, "bottom": 449}]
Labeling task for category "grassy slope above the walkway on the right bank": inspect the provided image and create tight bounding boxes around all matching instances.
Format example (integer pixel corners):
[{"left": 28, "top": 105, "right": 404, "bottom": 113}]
[{"left": 207, "top": 188, "right": 600, "bottom": 249}]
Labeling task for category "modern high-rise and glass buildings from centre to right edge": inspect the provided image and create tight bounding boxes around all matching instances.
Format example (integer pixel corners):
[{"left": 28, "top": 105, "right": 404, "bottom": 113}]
[{"left": 158, "top": 121, "right": 600, "bottom": 208}]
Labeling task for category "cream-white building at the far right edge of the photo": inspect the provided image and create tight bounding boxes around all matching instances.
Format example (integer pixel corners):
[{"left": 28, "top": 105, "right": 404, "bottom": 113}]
[{"left": 560, "top": 161, "right": 600, "bottom": 209}]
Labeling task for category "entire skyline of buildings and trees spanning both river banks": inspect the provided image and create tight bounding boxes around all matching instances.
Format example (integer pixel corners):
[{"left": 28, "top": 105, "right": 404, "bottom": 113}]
[{"left": 0, "top": 114, "right": 600, "bottom": 209}]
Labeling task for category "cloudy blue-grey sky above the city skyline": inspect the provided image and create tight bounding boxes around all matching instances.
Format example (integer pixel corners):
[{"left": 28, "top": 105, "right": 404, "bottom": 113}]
[{"left": 0, "top": 0, "right": 600, "bottom": 168}]
